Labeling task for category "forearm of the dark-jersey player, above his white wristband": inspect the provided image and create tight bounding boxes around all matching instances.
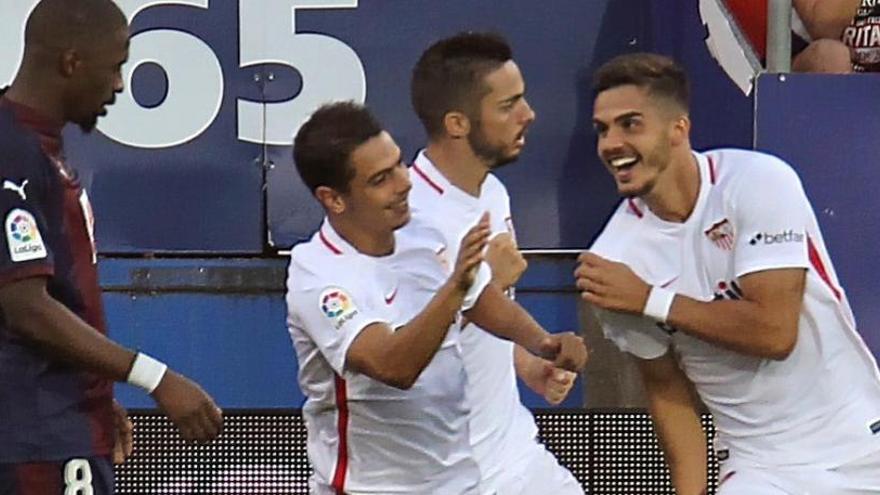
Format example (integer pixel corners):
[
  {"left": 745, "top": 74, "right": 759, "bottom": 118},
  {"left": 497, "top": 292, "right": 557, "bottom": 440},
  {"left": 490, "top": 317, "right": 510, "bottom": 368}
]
[{"left": 4, "top": 296, "right": 135, "bottom": 381}]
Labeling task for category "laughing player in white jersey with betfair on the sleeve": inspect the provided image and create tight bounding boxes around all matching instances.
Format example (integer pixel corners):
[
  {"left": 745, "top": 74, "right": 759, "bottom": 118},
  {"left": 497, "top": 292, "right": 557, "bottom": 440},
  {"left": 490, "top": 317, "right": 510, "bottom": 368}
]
[{"left": 575, "top": 54, "right": 880, "bottom": 495}]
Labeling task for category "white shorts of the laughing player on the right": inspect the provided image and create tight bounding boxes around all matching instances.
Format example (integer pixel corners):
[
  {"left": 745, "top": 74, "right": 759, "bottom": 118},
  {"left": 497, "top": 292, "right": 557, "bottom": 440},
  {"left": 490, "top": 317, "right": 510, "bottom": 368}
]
[{"left": 716, "top": 452, "right": 880, "bottom": 495}]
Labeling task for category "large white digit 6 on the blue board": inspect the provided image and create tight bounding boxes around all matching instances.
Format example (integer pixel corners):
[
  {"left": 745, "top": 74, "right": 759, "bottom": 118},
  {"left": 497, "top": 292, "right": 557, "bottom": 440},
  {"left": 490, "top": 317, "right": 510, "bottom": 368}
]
[{"left": 98, "top": 0, "right": 223, "bottom": 148}]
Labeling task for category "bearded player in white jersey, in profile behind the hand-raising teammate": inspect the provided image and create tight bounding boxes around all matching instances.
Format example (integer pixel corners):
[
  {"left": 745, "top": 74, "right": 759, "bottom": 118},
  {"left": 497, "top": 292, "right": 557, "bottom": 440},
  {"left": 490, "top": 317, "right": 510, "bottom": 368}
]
[{"left": 411, "top": 33, "right": 583, "bottom": 495}]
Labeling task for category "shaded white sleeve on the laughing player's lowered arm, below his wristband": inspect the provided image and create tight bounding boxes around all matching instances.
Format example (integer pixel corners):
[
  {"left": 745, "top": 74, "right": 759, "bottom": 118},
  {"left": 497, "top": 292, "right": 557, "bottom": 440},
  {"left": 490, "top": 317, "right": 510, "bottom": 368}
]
[{"left": 594, "top": 308, "right": 672, "bottom": 359}]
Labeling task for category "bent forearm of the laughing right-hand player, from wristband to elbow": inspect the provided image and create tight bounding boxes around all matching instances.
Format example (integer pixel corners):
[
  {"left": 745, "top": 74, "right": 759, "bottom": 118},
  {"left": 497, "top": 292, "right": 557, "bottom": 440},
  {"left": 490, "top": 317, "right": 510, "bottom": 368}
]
[{"left": 666, "top": 294, "right": 797, "bottom": 359}]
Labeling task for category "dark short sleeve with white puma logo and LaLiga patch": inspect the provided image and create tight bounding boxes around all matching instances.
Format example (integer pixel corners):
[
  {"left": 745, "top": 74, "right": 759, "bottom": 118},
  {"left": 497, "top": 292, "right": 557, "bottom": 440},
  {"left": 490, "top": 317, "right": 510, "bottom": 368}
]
[{"left": 0, "top": 140, "right": 54, "bottom": 286}]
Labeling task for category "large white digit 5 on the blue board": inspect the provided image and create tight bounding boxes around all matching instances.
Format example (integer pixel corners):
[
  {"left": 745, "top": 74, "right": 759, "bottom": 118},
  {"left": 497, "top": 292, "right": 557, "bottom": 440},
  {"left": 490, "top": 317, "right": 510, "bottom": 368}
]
[{"left": 238, "top": 0, "right": 367, "bottom": 145}]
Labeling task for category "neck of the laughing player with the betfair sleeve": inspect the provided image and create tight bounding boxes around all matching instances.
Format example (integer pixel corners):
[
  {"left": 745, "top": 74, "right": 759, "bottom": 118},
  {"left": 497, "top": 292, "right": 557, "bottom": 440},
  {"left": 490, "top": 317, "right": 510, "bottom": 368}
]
[{"left": 642, "top": 147, "right": 700, "bottom": 223}]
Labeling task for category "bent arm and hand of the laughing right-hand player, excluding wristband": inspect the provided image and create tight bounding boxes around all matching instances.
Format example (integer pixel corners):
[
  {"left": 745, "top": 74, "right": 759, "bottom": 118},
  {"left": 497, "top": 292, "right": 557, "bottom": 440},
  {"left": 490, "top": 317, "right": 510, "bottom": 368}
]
[{"left": 575, "top": 252, "right": 806, "bottom": 360}]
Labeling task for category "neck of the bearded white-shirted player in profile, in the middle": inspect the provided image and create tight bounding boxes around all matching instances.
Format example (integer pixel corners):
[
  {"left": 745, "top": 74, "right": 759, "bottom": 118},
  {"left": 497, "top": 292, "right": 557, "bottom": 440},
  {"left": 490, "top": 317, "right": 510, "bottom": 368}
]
[{"left": 425, "top": 137, "right": 491, "bottom": 198}]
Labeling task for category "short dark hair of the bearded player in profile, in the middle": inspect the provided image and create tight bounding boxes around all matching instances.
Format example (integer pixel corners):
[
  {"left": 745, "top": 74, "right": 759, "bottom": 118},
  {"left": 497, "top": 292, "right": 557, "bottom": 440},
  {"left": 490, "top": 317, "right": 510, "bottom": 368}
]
[{"left": 410, "top": 32, "right": 513, "bottom": 137}]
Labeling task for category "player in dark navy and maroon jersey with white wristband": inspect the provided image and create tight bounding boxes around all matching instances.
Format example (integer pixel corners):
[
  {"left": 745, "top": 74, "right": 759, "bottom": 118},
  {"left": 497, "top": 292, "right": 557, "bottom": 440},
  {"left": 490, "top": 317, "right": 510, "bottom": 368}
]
[{"left": 0, "top": 0, "right": 222, "bottom": 495}]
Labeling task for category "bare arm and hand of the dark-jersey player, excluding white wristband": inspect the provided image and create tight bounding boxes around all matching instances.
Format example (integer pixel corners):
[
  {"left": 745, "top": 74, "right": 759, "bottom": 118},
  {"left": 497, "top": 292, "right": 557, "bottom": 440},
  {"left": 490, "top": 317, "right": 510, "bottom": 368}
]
[{"left": 0, "top": 277, "right": 223, "bottom": 442}]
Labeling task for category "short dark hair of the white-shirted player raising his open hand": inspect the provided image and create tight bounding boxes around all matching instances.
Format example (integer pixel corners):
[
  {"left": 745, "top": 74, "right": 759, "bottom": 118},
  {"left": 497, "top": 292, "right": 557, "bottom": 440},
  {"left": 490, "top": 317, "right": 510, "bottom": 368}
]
[{"left": 293, "top": 101, "right": 383, "bottom": 193}]
